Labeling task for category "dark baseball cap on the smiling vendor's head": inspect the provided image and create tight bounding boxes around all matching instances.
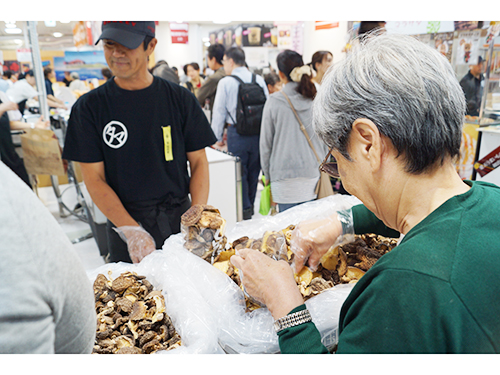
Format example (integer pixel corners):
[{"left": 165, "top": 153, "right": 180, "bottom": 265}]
[{"left": 95, "top": 21, "right": 155, "bottom": 49}]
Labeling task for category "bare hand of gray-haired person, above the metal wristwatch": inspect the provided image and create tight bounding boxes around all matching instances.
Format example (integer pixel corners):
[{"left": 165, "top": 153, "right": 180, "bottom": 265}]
[{"left": 231, "top": 249, "right": 304, "bottom": 319}]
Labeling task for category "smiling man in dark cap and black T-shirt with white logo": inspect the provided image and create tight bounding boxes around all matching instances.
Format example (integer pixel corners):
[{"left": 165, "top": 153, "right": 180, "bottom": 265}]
[{"left": 63, "top": 21, "right": 217, "bottom": 263}]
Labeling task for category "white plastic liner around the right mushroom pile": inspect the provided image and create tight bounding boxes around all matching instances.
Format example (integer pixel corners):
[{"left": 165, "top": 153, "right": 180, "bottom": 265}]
[{"left": 161, "top": 195, "right": 359, "bottom": 354}]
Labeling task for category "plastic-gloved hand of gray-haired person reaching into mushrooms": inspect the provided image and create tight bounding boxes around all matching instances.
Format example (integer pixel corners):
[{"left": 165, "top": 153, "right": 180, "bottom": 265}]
[{"left": 290, "top": 213, "right": 342, "bottom": 273}]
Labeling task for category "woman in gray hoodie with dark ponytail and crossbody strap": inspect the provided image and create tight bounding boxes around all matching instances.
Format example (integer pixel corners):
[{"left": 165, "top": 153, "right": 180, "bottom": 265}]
[{"left": 260, "top": 50, "right": 328, "bottom": 212}]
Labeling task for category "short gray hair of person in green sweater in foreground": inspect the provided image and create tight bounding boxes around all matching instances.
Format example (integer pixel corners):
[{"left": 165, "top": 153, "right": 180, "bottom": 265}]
[{"left": 313, "top": 34, "right": 466, "bottom": 174}]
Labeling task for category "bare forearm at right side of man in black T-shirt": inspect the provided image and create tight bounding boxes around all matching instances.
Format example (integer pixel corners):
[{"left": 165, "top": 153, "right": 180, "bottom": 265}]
[{"left": 187, "top": 148, "right": 210, "bottom": 205}]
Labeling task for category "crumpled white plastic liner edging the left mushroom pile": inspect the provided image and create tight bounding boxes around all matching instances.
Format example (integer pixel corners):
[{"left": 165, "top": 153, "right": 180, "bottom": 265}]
[{"left": 87, "top": 256, "right": 223, "bottom": 354}]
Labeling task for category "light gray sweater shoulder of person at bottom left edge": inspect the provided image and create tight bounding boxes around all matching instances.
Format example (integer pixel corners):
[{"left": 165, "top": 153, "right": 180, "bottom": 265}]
[{"left": 0, "top": 162, "right": 96, "bottom": 354}]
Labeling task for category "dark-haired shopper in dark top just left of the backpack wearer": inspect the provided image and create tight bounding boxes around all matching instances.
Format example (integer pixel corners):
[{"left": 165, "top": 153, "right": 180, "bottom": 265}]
[{"left": 196, "top": 43, "right": 226, "bottom": 119}]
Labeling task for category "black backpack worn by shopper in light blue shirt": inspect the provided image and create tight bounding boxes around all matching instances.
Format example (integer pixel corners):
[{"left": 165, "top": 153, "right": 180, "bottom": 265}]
[{"left": 229, "top": 73, "right": 266, "bottom": 135}]
